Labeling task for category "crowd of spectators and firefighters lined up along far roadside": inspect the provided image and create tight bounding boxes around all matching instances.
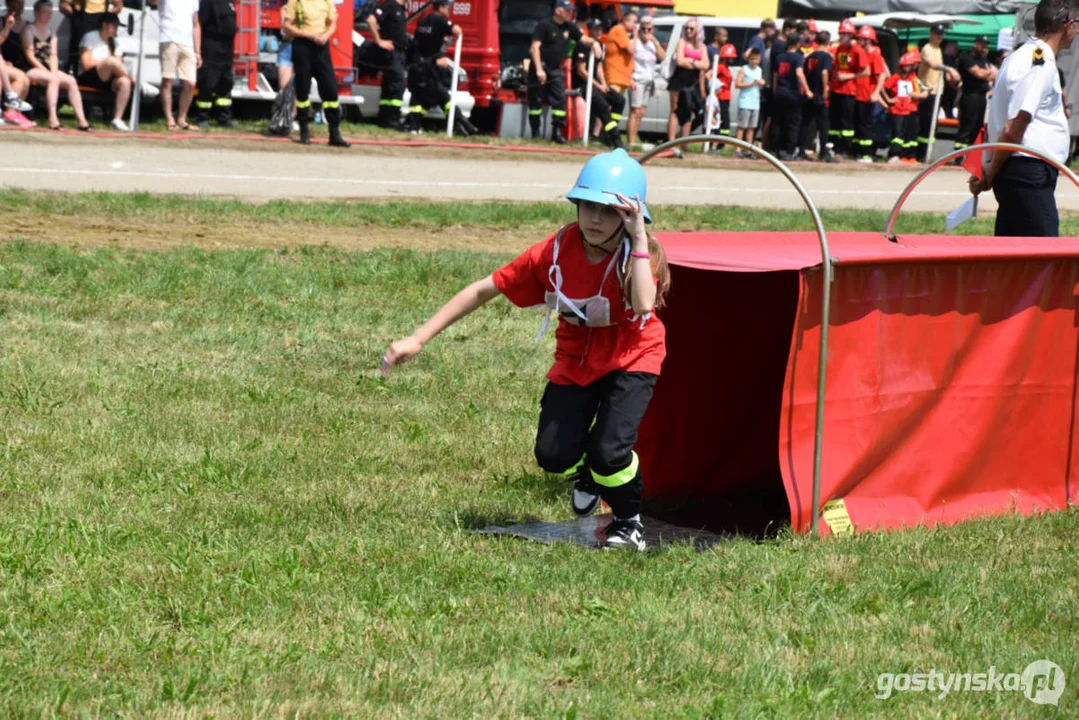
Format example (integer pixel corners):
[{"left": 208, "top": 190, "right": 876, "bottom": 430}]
[{"left": 0, "top": 0, "right": 1022, "bottom": 163}]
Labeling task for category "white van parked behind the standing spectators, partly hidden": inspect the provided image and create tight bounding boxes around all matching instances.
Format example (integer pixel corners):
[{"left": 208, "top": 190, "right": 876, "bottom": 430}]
[{"left": 641, "top": 15, "right": 839, "bottom": 135}]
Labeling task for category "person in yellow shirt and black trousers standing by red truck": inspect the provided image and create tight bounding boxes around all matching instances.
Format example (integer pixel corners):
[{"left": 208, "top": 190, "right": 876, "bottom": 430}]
[{"left": 281, "top": 0, "right": 350, "bottom": 148}]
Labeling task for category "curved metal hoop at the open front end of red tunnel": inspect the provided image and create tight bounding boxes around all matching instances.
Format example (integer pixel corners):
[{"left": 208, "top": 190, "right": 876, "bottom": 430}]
[{"left": 640, "top": 135, "right": 835, "bottom": 534}]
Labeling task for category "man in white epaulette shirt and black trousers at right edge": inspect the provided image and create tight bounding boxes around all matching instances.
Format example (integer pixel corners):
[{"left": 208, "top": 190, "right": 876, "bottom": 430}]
[{"left": 970, "top": 0, "right": 1079, "bottom": 237}]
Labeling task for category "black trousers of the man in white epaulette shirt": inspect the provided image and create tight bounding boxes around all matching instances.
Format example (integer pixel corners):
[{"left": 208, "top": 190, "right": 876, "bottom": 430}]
[{"left": 993, "top": 157, "right": 1061, "bottom": 237}]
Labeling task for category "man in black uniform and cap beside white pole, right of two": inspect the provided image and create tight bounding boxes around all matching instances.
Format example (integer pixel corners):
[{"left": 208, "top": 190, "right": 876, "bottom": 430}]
[{"left": 408, "top": 0, "right": 478, "bottom": 136}]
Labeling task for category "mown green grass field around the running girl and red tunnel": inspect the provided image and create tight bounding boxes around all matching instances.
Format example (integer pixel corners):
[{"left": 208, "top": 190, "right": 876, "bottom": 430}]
[{"left": 0, "top": 193, "right": 1079, "bottom": 718}]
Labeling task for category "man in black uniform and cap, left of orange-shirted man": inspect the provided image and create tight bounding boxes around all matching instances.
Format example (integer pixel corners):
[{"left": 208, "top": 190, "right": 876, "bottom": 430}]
[{"left": 528, "top": 0, "right": 596, "bottom": 145}]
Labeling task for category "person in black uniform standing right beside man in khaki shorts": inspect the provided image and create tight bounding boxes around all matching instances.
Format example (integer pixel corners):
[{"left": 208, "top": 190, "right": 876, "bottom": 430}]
[{"left": 195, "top": 0, "right": 236, "bottom": 128}]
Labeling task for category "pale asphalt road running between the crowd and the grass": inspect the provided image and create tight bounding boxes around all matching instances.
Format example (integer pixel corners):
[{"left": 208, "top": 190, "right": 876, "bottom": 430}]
[{"left": 0, "top": 131, "right": 1079, "bottom": 213}]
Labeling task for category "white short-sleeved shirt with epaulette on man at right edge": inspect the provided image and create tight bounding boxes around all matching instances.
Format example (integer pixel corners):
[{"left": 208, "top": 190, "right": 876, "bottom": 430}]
[{"left": 988, "top": 38, "right": 1071, "bottom": 163}]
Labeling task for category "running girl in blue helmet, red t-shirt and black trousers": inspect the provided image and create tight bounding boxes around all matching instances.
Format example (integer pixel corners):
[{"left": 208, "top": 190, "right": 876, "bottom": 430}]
[{"left": 383, "top": 150, "right": 670, "bottom": 549}]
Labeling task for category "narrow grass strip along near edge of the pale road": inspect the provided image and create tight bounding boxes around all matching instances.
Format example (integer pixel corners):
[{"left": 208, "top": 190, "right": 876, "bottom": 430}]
[{"left": 0, "top": 190, "right": 1079, "bottom": 236}]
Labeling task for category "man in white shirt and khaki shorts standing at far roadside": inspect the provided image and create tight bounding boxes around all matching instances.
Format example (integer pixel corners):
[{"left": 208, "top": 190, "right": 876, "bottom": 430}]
[{"left": 158, "top": 0, "right": 202, "bottom": 130}]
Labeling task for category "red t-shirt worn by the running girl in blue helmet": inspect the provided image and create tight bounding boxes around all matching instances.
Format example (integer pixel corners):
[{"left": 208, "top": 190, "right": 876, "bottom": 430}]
[{"left": 493, "top": 223, "right": 667, "bottom": 385}]
